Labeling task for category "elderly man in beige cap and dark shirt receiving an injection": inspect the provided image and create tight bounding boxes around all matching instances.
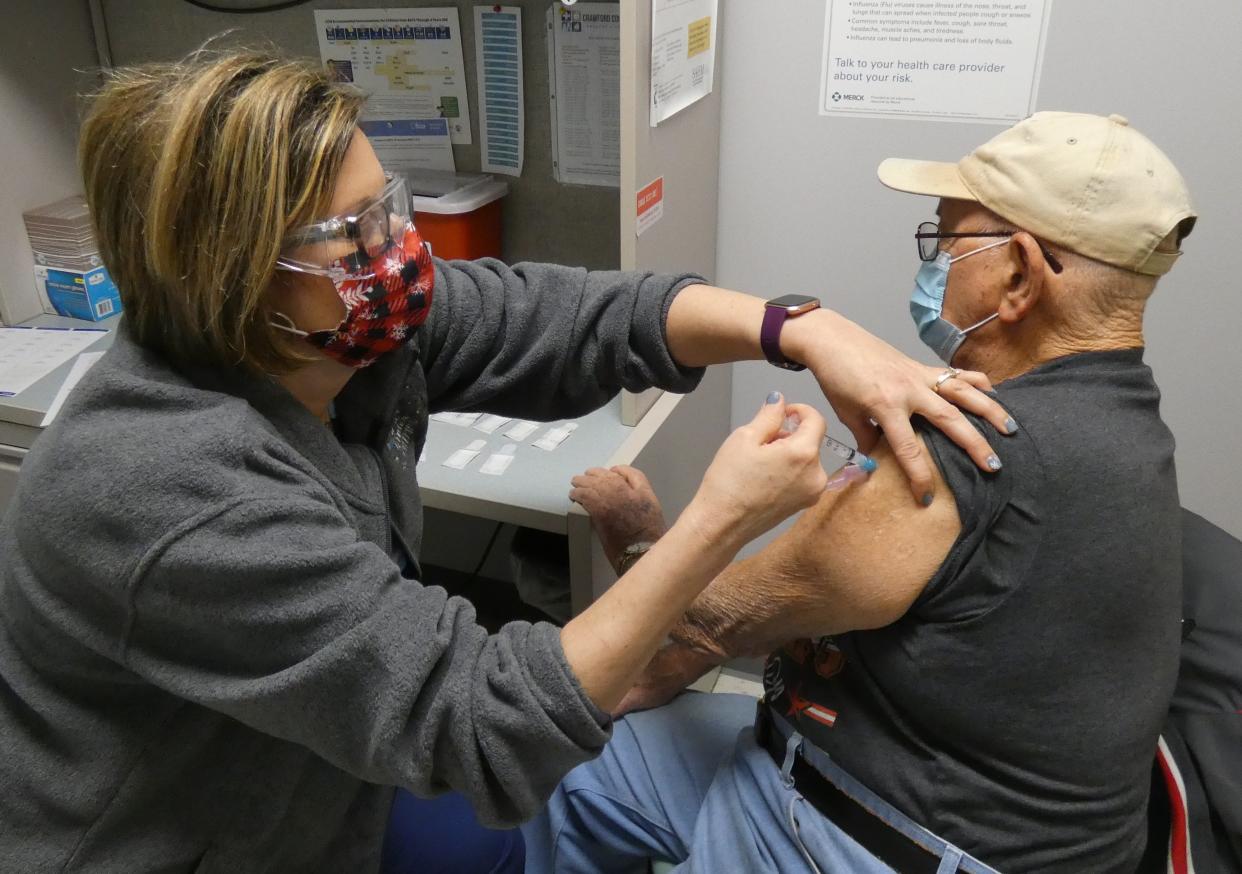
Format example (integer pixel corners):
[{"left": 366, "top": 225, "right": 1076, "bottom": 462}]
[{"left": 527, "top": 113, "right": 1195, "bottom": 873}]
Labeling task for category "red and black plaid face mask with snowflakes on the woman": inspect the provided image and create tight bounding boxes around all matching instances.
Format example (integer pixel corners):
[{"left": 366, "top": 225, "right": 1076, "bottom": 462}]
[{"left": 277, "top": 222, "right": 436, "bottom": 367}]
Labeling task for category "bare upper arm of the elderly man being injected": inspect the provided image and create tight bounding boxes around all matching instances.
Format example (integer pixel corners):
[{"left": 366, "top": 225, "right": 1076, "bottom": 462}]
[{"left": 756, "top": 442, "right": 961, "bottom": 637}]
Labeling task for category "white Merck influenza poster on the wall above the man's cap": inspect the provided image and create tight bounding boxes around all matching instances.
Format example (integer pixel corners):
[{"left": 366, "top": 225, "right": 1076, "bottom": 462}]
[{"left": 820, "top": 0, "right": 1052, "bottom": 124}]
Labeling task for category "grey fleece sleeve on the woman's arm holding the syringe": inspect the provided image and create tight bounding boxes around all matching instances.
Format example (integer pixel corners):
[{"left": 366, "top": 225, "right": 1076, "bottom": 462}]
[{"left": 123, "top": 497, "right": 611, "bottom": 827}]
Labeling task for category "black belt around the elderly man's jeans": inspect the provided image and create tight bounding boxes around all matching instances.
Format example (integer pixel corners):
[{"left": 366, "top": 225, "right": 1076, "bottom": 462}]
[{"left": 755, "top": 701, "right": 940, "bottom": 874}]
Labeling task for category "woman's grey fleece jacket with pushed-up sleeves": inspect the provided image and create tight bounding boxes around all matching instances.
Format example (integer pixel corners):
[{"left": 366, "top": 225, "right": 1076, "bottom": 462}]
[{"left": 0, "top": 255, "right": 700, "bottom": 874}]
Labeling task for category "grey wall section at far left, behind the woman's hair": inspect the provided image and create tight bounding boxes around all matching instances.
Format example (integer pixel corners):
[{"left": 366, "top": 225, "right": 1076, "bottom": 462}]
[{"left": 0, "top": 0, "right": 98, "bottom": 324}]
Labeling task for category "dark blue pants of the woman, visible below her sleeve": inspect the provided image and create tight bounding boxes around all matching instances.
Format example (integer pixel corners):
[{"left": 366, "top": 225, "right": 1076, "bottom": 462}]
[{"left": 380, "top": 788, "right": 525, "bottom": 874}]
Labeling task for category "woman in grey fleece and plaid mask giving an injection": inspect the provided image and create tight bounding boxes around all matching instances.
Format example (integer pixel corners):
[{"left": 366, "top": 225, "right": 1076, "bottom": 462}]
[{"left": 0, "top": 52, "right": 1005, "bottom": 872}]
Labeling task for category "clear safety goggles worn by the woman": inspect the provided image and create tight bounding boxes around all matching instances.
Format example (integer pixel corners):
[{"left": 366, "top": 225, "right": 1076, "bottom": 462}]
[{"left": 276, "top": 175, "right": 412, "bottom": 279}]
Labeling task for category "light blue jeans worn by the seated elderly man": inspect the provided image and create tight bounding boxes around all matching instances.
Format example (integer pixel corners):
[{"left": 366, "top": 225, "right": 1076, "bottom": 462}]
[{"left": 522, "top": 693, "right": 993, "bottom": 874}]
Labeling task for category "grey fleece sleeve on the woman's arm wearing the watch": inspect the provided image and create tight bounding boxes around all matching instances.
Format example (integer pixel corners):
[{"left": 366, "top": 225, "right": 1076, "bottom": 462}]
[{"left": 420, "top": 258, "right": 703, "bottom": 418}]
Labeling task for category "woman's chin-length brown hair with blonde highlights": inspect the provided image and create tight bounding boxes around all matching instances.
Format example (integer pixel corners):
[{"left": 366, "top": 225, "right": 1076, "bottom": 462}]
[{"left": 78, "top": 51, "right": 365, "bottom": 374}]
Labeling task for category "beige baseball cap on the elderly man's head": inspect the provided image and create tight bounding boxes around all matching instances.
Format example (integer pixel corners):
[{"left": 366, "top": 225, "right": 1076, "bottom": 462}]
[{"left": 879, "top": 112, "right": 1196, "bottom": 276}]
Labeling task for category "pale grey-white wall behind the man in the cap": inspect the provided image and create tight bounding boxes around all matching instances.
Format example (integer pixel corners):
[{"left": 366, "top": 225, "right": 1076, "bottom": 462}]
[{"left": 717, "top": 0, "right": 1242, "bottom": 536}]
